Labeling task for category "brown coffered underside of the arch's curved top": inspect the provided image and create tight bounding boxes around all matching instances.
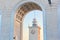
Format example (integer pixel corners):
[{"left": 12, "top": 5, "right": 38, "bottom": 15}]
[{"left": 16, "top": 2, "right": 42, "bottom": 21}]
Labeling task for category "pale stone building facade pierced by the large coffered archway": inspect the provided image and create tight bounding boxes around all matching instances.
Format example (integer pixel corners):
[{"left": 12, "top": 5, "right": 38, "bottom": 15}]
[{"left": 0, "top": 0, "right": 60, "bottom": 40}]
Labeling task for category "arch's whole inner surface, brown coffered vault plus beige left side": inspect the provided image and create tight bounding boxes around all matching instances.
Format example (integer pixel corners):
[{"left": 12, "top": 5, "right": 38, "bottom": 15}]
[{"left": 13, "top": 2, "right": 45, "bottom": 40}]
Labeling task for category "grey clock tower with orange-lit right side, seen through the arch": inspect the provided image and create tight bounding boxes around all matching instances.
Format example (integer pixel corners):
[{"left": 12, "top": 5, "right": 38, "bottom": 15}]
[{"left": 29, "top": 18, "right": 40, "bottom": 40}]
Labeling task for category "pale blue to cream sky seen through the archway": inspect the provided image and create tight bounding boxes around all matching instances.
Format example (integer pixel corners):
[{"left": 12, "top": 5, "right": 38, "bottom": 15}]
[{"left": 23, "top": 10, "right": 43, "bottom": 40}]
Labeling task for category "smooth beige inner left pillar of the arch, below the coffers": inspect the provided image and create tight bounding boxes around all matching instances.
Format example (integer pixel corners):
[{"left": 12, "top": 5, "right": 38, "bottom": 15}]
[{"left": 14, "top": 20, "right": 23, "bottom": 40}]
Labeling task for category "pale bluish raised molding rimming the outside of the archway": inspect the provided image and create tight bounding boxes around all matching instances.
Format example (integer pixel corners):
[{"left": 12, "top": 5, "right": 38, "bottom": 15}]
[{"left": 10, "top": 0, "right": 45, "bottom": 39}]
